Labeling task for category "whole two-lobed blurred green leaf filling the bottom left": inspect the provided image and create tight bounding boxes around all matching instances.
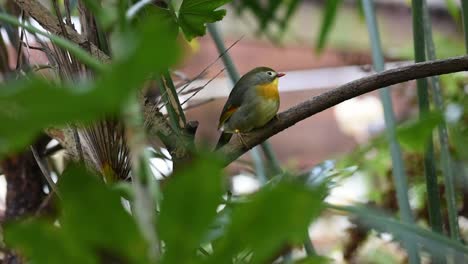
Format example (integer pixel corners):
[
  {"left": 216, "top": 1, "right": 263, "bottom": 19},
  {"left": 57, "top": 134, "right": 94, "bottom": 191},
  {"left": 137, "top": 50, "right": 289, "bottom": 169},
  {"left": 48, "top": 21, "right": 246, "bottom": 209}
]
[{"left": 5, "top": 165, "right": 148, "bottom": 263}]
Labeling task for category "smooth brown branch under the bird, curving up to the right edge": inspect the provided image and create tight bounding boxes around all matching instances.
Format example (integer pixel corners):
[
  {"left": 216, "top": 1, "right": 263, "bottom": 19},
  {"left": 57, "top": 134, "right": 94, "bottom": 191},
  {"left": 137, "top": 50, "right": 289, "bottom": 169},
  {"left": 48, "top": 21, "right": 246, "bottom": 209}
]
[{"left": 218, "top": 56, "right": 468, "bottom": 163}]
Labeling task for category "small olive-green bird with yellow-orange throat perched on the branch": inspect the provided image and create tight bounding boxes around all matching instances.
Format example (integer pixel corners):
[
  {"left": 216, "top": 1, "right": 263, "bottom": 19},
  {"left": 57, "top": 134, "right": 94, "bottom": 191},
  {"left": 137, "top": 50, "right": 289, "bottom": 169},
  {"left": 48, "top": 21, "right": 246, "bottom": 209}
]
[{"left": 216, "top": 67, "right": 285, "bottom": 149}]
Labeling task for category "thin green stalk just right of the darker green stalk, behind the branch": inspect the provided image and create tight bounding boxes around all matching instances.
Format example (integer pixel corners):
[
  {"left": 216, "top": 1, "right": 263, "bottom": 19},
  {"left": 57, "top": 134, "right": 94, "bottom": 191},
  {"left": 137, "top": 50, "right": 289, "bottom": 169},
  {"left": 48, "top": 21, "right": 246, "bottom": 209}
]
[{"left": 423, "top": 1, "right": 460, "bottom": 240}]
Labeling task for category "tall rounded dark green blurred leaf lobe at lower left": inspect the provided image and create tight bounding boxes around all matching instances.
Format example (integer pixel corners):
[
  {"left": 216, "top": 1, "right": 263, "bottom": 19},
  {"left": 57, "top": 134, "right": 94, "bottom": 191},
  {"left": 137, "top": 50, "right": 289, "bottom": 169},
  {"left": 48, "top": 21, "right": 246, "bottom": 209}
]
[{"left": 58, "top": 166, "right": 147, "bottom": 263}]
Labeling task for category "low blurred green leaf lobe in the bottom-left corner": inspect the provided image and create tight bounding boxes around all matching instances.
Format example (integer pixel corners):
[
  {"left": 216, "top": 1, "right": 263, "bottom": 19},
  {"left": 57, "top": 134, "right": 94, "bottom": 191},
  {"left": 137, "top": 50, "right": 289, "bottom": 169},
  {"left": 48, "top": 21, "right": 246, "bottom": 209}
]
[{"left": 5, "top": 220, "right": 98, "bottom": 264}]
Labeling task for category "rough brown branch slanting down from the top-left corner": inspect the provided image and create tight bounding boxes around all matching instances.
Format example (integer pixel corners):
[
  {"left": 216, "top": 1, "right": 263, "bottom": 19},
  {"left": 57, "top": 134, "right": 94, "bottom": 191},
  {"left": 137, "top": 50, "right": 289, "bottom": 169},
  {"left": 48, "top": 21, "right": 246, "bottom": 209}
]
[{"left": 14, "top": 0, "right": 110, "bottom": 62}]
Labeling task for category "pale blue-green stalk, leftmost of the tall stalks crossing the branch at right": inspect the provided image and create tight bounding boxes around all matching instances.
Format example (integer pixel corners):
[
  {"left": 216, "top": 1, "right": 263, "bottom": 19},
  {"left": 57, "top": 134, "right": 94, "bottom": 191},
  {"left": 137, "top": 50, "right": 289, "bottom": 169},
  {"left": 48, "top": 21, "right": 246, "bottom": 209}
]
[{"left": 362, "top": 0, "right": 420, "bottom": 264}]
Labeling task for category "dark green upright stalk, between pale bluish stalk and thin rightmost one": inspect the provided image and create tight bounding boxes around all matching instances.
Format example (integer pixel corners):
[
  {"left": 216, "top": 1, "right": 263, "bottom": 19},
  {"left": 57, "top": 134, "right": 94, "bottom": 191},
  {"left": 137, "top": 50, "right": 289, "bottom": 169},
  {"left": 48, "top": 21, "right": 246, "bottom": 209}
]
[{"left": 412, "top": 0, "right": 442, "bottom": 237}]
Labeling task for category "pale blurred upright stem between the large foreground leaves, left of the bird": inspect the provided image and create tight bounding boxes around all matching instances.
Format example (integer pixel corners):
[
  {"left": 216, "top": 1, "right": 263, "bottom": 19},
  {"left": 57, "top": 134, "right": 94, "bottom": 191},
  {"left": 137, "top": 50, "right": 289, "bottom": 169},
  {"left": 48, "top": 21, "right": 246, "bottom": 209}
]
[{"left": 123, "top": 94, "right": 161, "bottom": 262}]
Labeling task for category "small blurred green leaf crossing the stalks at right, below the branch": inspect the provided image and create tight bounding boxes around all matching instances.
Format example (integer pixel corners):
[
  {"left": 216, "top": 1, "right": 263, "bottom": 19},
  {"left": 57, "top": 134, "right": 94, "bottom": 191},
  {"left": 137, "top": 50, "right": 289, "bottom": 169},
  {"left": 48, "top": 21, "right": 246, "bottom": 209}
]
[{"left": 397, "top": 112, "right": 443, "bottom": 151}]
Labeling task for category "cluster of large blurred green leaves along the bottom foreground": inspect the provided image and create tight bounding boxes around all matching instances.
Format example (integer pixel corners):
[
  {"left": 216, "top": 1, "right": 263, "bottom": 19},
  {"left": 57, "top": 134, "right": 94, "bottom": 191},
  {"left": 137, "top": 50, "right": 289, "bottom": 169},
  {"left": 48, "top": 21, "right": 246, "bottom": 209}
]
[{"left": 5, "top": 155, "right": 327, "bottom": 263}]
